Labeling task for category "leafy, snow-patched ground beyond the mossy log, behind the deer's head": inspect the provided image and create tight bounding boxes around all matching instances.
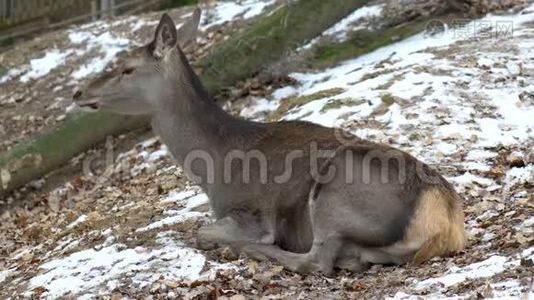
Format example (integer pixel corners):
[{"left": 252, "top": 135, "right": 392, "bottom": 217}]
[{"left": 0, "top": 0, "right": 277, "bottom": 151}]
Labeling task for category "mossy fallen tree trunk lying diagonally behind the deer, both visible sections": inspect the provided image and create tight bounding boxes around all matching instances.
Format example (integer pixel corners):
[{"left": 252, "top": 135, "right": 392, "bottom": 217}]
[{"left": 0, "top": 0, "right": 368, "bottom": 195}]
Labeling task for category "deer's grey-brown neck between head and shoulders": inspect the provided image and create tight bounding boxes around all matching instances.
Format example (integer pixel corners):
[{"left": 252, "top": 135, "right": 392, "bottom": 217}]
[{"left": 152, "top": 51, "right": 265, "bottom": 180}]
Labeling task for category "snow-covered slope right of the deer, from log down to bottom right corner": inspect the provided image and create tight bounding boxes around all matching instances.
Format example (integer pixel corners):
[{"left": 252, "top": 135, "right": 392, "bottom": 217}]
[{"left": 241, "top": 6, "right": 534, "bottom": 299}]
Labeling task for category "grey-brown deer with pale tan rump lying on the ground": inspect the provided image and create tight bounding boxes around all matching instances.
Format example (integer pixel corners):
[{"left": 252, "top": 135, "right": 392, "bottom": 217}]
[{"left": 74, "top": 9, "right": 466, "bottom": 273}]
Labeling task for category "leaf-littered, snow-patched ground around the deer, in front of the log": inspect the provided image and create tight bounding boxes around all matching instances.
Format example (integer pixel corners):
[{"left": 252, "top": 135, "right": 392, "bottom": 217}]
[{"left": 0, "top": 1, "right": 534, "bottom": 300}]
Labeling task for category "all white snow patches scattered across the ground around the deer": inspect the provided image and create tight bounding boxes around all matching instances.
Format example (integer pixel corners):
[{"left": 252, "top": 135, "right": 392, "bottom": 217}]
[{"left": 5, "top": 0, "right": 534, "bottom": 299}]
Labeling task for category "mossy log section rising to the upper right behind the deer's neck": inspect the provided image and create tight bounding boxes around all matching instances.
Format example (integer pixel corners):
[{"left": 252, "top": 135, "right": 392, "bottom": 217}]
[{"left": 201, "top": 0, "right": 369, "bottom": 90}]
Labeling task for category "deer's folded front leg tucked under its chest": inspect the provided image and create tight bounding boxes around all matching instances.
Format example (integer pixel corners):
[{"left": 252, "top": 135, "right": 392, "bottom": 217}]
[{"left": 197, "top": 215, "right": 264, "bottom": 250}]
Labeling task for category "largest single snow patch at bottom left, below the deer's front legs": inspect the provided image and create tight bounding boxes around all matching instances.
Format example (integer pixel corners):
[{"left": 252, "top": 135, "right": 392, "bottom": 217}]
[{"left": 30, "top": 239, "right": 206, "bottom": 298}]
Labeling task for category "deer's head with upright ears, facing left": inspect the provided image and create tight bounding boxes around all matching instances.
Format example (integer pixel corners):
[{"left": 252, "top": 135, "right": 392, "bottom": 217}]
[{"left": 73, "top": 8, "right": 200, "bottom": 115}]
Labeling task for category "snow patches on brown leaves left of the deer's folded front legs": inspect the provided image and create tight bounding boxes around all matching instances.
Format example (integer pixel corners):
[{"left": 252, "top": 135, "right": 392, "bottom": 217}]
[{"left": 24, "top": 188, "right": 229, "bottom": 298}]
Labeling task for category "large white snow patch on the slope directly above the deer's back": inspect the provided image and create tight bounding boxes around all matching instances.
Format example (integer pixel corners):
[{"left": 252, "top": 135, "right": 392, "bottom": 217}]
[{"left": 241, "top": 2, "right": 534, "bottom": 178}]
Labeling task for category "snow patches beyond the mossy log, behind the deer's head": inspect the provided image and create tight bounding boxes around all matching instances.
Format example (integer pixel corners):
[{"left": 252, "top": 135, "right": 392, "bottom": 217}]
[{"left": 0, "top": 0, "right": 275, "bottom": 83}]
